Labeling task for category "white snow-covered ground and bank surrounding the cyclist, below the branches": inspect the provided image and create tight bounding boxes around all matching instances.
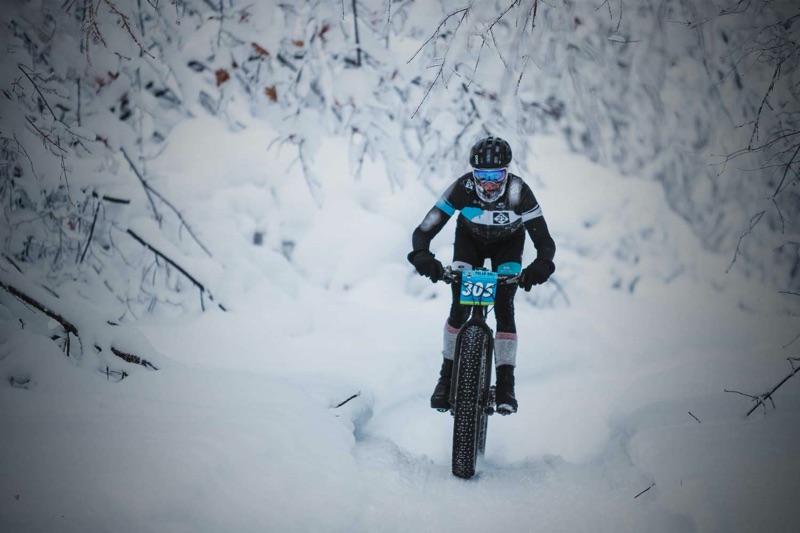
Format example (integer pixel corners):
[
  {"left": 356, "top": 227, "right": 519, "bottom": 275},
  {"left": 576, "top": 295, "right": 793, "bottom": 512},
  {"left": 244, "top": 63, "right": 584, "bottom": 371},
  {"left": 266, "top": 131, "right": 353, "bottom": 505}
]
[{"left": 0, "top": 130, "right": 800, "bottom": 533}]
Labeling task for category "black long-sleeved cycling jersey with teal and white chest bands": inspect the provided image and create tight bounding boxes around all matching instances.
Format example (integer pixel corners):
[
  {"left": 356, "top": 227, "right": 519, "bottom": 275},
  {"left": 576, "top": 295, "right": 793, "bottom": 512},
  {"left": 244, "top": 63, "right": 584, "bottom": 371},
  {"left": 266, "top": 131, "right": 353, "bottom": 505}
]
[{"left": 411, "top": 172, "right": 556, "bottom": 261}]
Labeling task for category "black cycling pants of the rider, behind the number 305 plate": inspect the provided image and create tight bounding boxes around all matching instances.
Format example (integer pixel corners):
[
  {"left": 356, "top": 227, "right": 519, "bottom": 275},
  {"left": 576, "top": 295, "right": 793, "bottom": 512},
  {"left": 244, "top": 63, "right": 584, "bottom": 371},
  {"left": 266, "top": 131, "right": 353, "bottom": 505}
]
[{"left": 447, "top": 224, "right": 525, "bottom": 333}]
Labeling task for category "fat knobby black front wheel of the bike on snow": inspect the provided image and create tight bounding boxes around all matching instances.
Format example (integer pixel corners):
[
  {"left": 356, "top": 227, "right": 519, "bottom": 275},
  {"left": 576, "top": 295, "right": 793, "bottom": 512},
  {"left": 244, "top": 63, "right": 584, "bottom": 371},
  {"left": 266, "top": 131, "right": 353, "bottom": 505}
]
[{"left": 452, "top": 324, "right": 491, "bottom": 479}]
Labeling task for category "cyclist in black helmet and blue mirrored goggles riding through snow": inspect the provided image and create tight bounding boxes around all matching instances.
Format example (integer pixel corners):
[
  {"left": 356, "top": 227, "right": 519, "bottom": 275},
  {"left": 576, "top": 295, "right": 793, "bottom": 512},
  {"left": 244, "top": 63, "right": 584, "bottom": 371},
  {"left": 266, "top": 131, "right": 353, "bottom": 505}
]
[{"left": 408, "top": 136, "right": 556, "bottom": 415}]
